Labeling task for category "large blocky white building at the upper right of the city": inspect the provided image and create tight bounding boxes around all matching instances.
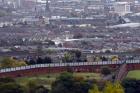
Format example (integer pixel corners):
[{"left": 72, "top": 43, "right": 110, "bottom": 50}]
[{"left": 114, "top": 2, "right": 131, "bottom": 16}]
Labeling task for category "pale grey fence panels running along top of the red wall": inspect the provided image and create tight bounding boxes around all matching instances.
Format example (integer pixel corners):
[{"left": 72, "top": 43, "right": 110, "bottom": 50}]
[{"left": 0, "top": 60, "right": 140, "bottom": 73}]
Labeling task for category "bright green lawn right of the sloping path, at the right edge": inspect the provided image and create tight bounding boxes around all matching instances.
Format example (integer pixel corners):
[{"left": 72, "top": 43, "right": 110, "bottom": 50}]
[{"left": 126, "top": 70, "right": 140, "bottom": 80}]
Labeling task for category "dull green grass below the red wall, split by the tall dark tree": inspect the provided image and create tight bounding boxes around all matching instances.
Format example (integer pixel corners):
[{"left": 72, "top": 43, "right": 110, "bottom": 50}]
[{"left": 16, "top": 73, "right": 101, "bottom": 88}]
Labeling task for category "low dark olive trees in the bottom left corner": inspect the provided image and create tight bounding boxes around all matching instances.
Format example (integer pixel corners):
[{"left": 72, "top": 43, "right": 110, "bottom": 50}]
[{"left": 0, "top": 78, "right": 49, "bottom": 93}]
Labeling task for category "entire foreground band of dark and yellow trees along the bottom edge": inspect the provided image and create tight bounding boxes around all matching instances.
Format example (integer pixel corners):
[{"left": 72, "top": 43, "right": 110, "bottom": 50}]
[{"left": 0, "top": 72, "right": 140, "bottom": 93}]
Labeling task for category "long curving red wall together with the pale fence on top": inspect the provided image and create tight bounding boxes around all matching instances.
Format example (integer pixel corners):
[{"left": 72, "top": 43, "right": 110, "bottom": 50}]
[{"left": 0, "top": 60, "right": 140, "bottom": 77}]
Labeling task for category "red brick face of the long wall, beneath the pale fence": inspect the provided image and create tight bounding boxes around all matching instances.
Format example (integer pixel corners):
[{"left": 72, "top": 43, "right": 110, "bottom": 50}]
[{"left": 0, "top": 64, "right": 140, "bottom": 78}]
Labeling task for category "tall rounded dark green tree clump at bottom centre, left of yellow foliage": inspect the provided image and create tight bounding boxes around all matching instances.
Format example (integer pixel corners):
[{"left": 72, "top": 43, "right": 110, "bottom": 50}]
[{"left": 51, "top": 72, "right": 89, "bottom": 93}]
